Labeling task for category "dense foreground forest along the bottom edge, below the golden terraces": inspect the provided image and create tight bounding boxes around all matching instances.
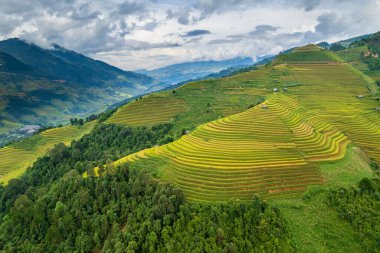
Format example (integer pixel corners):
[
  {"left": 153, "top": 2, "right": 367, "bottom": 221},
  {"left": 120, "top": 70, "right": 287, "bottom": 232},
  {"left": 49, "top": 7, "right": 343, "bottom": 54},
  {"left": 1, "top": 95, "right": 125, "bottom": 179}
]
[{"left": 0, "top": 168, "right": 291, "bottom": 252}]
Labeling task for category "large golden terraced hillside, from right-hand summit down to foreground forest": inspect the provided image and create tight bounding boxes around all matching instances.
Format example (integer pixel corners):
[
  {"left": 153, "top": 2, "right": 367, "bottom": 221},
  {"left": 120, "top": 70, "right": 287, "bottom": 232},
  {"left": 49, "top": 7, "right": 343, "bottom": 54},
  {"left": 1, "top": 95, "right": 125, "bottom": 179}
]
[{"left": 104, "top": 45, "right": 380, "bottom": 201}]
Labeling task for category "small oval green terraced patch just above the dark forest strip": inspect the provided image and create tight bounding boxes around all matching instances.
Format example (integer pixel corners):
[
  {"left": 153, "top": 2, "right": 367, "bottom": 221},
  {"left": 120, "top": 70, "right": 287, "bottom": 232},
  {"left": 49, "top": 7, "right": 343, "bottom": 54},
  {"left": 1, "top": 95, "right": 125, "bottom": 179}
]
[{"left": 107, "top": 95, "right": 186, "bottom": 126}]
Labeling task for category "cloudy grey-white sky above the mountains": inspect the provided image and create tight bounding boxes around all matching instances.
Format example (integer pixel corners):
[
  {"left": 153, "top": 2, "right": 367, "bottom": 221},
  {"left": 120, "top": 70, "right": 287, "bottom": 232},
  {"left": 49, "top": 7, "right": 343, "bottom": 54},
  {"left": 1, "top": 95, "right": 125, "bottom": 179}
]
[{"left": 0, "top": 0, "right": 380, "bottom": 70}]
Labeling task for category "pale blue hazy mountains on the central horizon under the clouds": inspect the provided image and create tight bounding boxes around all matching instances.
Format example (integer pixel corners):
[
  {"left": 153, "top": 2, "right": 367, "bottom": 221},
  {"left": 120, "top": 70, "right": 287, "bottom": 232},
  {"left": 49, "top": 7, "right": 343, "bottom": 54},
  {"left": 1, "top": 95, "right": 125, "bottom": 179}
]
[{"left": 136, "top": 57, "right": 261, "bottom": 85}]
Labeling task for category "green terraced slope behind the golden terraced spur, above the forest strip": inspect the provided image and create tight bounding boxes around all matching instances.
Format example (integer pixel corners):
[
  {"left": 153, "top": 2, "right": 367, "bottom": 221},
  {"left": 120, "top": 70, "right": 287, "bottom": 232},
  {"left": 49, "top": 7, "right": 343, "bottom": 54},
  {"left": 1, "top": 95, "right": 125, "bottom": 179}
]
[{"left": 107, "top": 69, "right": 273, "bottom": 133}]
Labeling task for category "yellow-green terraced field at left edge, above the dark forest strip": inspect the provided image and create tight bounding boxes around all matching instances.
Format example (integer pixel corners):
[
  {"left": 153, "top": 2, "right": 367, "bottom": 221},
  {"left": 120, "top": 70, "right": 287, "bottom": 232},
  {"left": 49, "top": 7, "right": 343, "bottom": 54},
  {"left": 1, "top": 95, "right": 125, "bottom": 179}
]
[{"left": 0, "top": 121, "right": 95, "bottom": 183}]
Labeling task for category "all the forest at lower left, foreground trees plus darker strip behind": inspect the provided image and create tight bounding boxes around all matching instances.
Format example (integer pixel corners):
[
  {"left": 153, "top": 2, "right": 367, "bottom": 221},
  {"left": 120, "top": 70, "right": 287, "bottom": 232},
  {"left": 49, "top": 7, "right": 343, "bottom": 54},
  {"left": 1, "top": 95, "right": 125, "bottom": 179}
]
[{"left": 0, "top": 124, "right": 291, "bottom": 252}]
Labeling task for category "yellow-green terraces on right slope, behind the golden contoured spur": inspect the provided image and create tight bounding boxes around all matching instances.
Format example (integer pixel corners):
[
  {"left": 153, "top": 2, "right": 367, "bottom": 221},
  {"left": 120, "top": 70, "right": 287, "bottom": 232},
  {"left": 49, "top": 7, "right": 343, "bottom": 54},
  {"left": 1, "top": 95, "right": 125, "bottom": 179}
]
[{"left": 286, "top": 64, "right": 380, "bottom": 163}]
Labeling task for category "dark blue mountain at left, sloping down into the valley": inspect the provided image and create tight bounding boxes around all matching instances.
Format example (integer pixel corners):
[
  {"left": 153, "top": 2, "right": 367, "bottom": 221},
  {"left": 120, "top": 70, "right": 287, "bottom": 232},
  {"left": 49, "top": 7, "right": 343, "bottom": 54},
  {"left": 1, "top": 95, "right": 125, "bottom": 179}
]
[{"left": 0, "top": 38, "right": 163, "bottom": 142}]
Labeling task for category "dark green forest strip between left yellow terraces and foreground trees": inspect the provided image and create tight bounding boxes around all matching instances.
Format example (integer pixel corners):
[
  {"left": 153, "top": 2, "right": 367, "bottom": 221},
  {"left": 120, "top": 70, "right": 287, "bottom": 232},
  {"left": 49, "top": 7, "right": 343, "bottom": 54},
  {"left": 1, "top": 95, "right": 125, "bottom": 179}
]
[{"left": 0, "top": 124, "right": 173, "bottom": 218}]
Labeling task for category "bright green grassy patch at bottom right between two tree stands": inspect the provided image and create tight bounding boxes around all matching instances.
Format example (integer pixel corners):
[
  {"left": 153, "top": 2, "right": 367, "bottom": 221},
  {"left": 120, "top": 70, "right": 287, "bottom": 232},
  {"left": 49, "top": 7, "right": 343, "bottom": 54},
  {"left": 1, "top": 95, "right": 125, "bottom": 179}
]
[{"left": 270, "top": 193, "right": 362, "bottom": 253}]
